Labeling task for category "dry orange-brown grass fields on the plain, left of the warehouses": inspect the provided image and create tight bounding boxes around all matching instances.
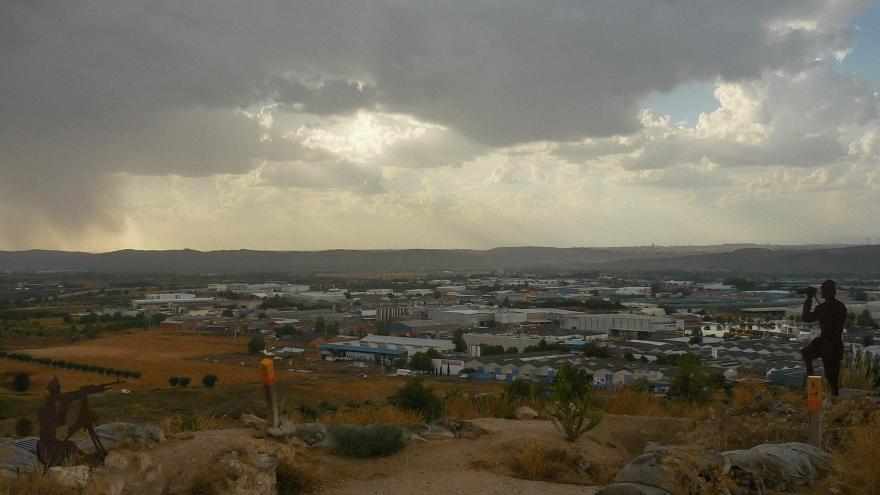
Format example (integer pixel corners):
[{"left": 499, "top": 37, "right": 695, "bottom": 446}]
[{"left": 0, "top": 330, "right": 503, "bottom": 430}]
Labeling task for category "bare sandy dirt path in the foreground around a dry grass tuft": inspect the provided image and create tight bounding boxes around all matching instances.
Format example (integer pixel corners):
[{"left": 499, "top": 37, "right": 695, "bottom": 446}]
[{"left": 305, "top": 415, "right": 693, "bottom": 495}]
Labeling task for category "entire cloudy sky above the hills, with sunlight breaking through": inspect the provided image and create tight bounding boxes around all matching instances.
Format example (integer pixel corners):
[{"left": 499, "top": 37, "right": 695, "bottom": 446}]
[{"left": 0, "top": 0, "right": 880, "bottom": 252}]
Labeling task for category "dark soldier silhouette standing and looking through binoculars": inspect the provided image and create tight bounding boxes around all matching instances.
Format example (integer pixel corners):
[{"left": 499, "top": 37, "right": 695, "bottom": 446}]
[{"left": 800, "top": 280, "right": 846, "bottom": 396}]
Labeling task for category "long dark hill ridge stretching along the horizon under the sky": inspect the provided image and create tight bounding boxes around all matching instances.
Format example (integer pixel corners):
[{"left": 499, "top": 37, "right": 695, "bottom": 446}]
[{"left": 0, "top": 245, "right": 880, "bottom": 275}]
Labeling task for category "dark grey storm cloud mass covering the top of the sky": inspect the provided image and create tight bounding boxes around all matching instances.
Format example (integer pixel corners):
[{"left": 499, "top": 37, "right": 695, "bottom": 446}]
[{"left": 0, "top": 0, "right": 865, "bottom": 244}]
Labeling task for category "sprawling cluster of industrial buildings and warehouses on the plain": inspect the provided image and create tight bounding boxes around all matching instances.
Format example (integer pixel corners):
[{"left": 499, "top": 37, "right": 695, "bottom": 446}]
[{"left": 113, "top": 276, "right": 880, "bottom": 388}]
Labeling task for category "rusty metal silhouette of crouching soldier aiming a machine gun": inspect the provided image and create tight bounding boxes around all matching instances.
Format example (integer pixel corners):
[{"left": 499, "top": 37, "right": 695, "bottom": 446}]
[{"left": 37, "top": 377, "right": 121, "bottom": 469}]
